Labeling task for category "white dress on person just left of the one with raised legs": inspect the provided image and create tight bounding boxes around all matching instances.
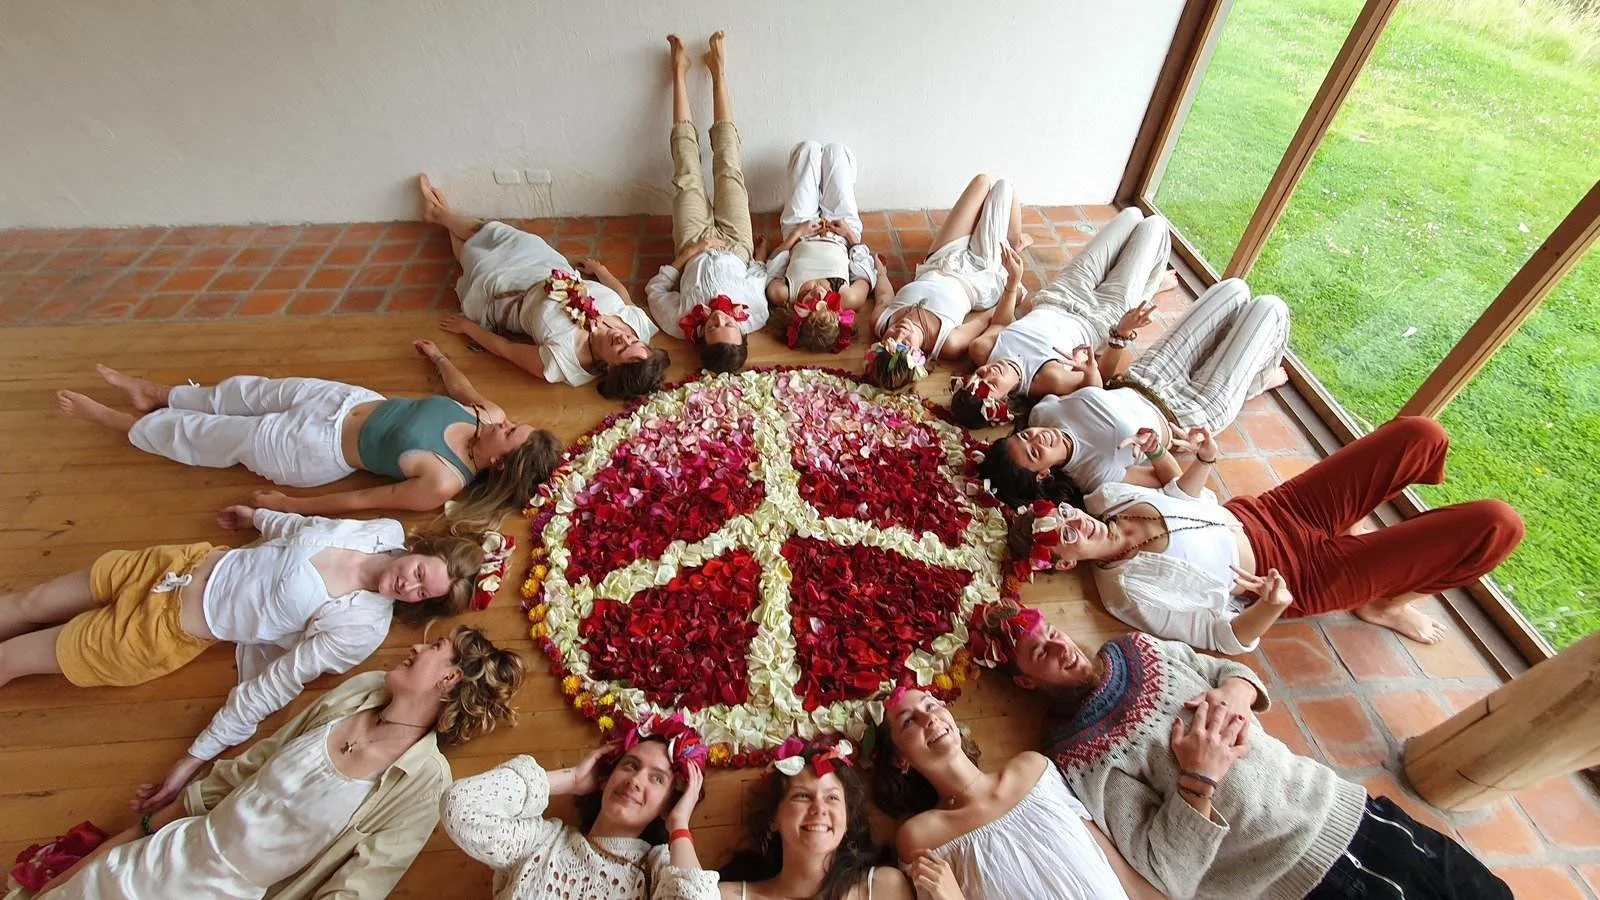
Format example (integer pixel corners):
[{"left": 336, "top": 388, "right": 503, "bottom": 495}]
[{"left": 456, "top": 223, "right": 656, "bottom": 384}]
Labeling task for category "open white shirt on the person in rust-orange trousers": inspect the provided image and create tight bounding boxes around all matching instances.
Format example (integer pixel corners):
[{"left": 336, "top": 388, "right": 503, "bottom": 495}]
[{"left": 1083, "top": 479, "right": 1259, "bottom": 655}]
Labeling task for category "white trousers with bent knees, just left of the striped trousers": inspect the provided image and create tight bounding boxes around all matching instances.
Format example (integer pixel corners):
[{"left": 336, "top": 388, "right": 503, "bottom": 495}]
[{"left": 1034, "top": 207, "right": 1173, "bottom": 339}]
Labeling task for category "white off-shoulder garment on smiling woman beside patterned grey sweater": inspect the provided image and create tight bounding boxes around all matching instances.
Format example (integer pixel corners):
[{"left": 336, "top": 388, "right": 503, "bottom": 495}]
[{"left": 933, "top": 765, "right": 1128, "bottom": 900}]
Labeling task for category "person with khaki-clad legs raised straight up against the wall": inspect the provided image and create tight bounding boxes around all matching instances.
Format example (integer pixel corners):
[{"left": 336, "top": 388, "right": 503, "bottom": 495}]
[{"left": 645, "top": 32, "right": 768, "bottom": 372}]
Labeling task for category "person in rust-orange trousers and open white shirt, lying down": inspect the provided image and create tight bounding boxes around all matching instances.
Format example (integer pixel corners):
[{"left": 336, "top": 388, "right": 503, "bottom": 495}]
[{"left": 1008, "top": 416, "right": 1523, "bottom": 643}]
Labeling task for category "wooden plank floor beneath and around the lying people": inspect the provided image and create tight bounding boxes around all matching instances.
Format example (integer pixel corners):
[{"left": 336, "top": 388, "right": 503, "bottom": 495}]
[{"left": 0, "top": 305, "right": 1120, "bottom": 897}]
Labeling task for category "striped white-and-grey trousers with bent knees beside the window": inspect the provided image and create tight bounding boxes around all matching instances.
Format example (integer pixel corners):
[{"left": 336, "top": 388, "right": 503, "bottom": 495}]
[{"left": 1125, "top": 279, "right": 1290, "bottom": 432}]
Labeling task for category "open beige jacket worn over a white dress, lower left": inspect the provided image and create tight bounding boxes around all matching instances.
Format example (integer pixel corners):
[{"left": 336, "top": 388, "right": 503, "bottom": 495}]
[{"left": 182, "top": 673, "right": 451, "bottom": 900}]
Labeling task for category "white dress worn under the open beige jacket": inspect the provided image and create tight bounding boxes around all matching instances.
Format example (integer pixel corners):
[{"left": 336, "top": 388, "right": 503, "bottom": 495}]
[{"left": 50, "top": 719, "right": 376, "bottom": 900}]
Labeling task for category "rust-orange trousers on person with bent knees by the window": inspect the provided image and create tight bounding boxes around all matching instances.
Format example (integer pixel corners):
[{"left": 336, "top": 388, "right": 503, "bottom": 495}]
[{"left": 1227, "top": 416, "right": 1523, "bottom": 615}]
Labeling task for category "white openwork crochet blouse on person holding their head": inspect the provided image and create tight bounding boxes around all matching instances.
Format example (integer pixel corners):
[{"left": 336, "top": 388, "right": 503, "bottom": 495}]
[{"left": 442, "top": 756, "right": 718, "bottom": 900}]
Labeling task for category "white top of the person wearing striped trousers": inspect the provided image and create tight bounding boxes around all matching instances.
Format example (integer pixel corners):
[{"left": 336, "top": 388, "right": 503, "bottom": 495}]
[{"left": 1027, "top": 384, "right": 1170, "bottom": 493}]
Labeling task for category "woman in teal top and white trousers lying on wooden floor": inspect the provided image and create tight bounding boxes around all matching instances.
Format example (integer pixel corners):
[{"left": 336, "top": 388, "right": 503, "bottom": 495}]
[{"left": 56, "top": 341, "right": 562, "bottom": 530}]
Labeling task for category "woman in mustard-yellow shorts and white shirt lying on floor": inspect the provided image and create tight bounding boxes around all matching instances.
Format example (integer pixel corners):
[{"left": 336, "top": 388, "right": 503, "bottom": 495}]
[{"left": 0, "top": 506, "right": 485, "bottom": 809}]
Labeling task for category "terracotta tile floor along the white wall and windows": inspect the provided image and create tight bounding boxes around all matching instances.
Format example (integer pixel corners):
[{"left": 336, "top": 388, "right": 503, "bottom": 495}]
[{"left": 0, "top": 207, "right": 1600, "bottom": 900}]
